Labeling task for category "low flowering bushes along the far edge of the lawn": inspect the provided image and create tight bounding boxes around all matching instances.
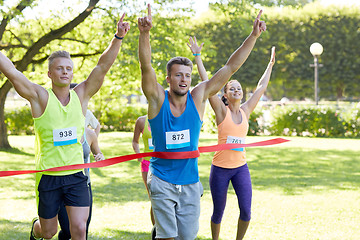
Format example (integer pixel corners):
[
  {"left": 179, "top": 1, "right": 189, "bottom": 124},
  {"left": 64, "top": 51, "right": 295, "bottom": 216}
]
[{"left": 5, "top": 103, "right": 360, "bottom": 137}]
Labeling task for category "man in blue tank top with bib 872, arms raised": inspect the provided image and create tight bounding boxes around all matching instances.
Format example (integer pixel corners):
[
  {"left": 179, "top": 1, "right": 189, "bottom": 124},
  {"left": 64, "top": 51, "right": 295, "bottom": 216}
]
[{"left": 138, "top": 5, "right": 265, "bottom": 240}]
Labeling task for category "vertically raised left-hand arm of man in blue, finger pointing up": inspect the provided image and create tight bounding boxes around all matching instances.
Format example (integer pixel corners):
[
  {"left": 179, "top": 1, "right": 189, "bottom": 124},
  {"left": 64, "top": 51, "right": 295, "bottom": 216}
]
[{"left": 138, "top": 4, "right": 165, "bottom": 115}]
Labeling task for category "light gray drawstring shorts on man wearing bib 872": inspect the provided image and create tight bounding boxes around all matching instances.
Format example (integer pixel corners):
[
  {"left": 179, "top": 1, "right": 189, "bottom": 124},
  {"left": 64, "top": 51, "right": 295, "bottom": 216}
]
[{"left": 147, "top": 170, "right": 203, "bottom": 240}]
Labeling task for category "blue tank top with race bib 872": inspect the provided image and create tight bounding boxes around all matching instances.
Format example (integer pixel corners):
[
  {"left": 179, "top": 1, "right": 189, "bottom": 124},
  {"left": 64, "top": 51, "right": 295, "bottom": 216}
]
[{"left": 149, "top": 91, "right": 202, "bottom": 185}]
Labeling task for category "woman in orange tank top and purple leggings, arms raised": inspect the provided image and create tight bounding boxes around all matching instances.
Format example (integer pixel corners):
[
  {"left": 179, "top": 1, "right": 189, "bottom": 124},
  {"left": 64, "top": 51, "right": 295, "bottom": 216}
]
[{"left": 189, "top": 38, "right": 275, "bottom": 240}]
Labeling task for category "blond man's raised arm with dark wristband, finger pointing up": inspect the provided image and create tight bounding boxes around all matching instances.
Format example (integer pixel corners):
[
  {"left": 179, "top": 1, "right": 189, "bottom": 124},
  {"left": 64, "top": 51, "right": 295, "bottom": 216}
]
[{"left": 74, "top": 13, "right": 130, "bottom": 108}]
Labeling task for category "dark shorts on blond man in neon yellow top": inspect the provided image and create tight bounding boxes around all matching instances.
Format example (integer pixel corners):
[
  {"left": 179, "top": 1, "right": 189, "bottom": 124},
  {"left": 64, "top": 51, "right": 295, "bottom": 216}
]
[{"left": 38, "top": 172, "right": 90, "bottom": 219}]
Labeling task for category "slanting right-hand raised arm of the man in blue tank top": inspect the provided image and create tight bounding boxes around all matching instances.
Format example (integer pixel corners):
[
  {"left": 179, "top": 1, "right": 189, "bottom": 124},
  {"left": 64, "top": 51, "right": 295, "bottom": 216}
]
[{"left": 204, "top": 10, "right": 266, "bottom": 98}]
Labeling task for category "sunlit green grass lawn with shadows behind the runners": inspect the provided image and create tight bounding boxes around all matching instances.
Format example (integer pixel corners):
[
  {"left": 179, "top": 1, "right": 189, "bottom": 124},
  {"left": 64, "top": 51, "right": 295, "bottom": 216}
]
[{"left": 0, "top": 132, "right": 360, "bottom": 240}]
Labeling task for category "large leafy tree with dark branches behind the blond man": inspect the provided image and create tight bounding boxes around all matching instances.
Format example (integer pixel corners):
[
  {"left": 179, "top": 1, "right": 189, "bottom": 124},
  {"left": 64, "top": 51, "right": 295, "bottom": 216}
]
[{"left": 0, "top": 0, "right": 191, "bottom": 148}]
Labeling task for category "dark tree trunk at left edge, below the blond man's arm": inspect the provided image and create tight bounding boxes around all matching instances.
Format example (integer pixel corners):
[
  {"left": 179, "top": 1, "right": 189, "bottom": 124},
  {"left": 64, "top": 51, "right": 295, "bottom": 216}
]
[{"left": 0, "top": 80, "right": 12, "bottom": 149}]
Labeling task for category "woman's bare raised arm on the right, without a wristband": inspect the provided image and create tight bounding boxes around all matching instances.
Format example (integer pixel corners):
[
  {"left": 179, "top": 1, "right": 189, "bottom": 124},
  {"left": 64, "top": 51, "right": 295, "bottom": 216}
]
[{"left": 241, "top": 47, "right": 275, "bottom": 119}]
